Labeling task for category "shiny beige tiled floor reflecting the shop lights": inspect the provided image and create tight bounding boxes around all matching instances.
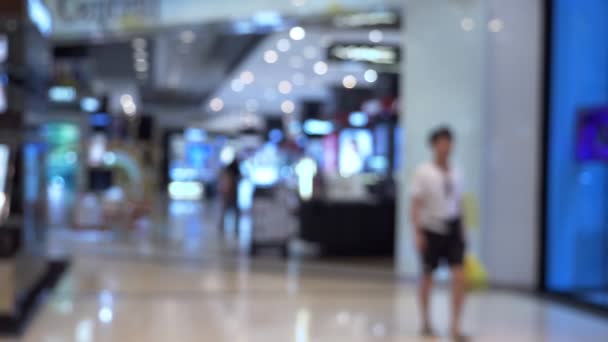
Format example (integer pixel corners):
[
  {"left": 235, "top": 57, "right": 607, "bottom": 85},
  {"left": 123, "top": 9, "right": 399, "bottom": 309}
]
[{"left": 10, "top": 202, "right": 608, "bottom": 342}]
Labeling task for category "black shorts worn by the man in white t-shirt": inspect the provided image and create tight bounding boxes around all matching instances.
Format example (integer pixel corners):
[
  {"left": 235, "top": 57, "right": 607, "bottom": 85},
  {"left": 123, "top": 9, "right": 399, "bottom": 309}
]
[{"left": 422, "top": 219, "right": 466, "bottom": 274}]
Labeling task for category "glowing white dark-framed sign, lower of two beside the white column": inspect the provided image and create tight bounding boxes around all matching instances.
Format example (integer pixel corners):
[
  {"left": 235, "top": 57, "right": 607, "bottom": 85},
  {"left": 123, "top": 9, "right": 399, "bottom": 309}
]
[{"left": 327, "top": 43, "right": 401, "bottom": 64}]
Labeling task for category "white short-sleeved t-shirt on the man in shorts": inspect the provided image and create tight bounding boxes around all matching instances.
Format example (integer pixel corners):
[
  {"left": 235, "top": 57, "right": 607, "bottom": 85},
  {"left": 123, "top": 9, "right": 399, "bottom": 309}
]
[{"left": 410, "top": 162, "right": 463, "bottom": 234}]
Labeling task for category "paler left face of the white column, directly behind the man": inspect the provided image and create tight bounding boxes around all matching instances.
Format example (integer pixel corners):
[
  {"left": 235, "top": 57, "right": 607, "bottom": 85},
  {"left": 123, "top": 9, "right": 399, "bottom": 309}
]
[{"left": 397, "top": 0, "right": 485, "bottom": 276}]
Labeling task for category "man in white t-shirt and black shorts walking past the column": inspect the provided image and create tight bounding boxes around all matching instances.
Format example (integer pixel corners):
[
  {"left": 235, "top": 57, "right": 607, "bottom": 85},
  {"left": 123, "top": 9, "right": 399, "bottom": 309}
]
[{"left": 411, "top": 127, "right": 468, "bottom": 341}]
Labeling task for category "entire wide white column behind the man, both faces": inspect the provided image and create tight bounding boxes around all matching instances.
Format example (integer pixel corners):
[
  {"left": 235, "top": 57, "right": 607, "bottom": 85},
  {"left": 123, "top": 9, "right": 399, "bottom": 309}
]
[{"left": 398, "top": 0, "right": 542, "bottom": 288}]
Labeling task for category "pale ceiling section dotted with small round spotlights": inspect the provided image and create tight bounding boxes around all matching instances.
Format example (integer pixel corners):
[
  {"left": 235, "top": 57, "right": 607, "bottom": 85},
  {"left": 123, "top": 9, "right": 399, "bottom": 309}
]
[{"left": 203, "top": 25, "right": 402, "bottom": 115}]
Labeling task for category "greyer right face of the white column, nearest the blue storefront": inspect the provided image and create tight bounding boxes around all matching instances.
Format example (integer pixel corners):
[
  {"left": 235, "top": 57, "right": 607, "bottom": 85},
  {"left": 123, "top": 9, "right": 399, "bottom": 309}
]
[{"left": 482, "top": 0, "right": 543, "bottom": 288}]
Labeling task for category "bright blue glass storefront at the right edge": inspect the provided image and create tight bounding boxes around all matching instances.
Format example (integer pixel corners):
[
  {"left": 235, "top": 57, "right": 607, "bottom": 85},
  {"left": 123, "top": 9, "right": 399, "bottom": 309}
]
[{"left": 544, "top": 0, "right": 608, "bottom": 308}]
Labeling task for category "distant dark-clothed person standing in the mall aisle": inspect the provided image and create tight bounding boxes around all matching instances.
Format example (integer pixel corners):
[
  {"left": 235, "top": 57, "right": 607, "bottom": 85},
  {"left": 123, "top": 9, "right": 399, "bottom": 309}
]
[{"left": 219, "top": 160, "right": 241, "bottom": 233}]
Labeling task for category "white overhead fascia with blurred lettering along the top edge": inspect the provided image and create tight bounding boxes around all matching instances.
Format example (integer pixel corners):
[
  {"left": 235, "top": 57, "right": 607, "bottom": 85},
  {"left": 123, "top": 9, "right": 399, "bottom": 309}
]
[{"left": 44, "top": 0, "right": 403, "bottom": 40}]
